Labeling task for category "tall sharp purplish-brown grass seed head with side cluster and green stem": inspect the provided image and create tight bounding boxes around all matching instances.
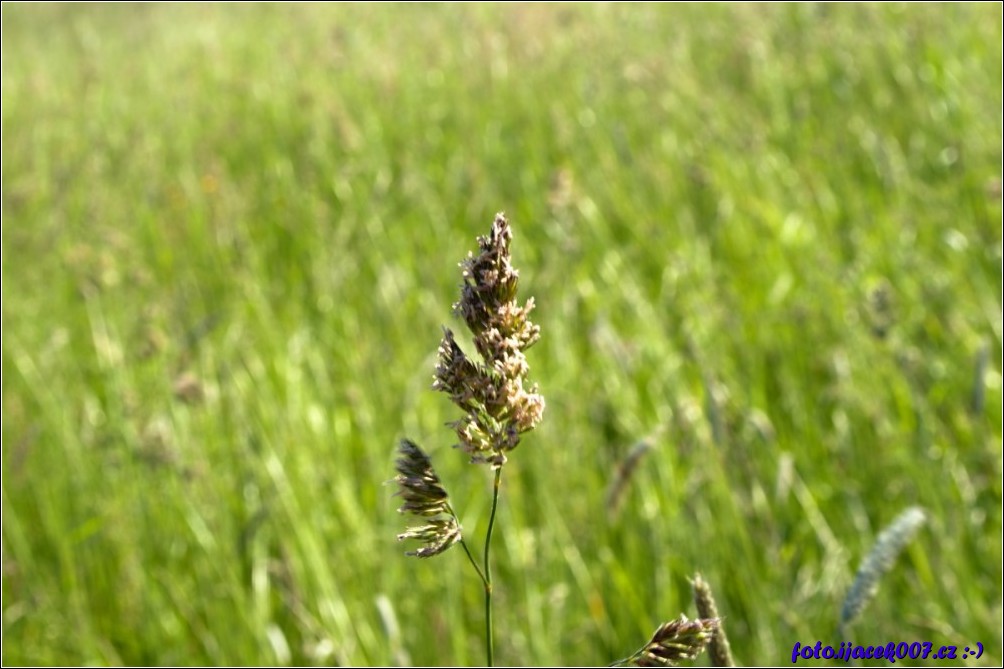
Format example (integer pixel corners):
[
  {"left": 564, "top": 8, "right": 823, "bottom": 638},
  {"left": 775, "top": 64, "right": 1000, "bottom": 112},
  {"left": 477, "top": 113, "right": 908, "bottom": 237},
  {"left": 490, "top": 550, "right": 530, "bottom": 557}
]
[{"left": 397, "top": 213, "right": 544, "bottom": 666}]
